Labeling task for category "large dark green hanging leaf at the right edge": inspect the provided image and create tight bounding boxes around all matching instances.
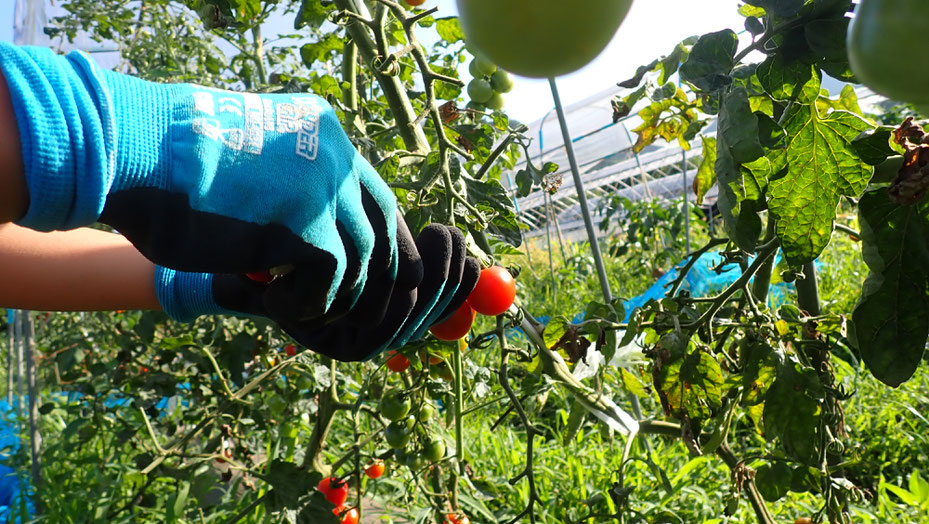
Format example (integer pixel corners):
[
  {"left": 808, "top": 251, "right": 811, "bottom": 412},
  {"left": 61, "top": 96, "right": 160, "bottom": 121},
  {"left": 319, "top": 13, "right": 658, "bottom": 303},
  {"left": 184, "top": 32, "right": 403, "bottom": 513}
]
[{"left": 851, "top": 188, "right": 929, "bottom": 387}]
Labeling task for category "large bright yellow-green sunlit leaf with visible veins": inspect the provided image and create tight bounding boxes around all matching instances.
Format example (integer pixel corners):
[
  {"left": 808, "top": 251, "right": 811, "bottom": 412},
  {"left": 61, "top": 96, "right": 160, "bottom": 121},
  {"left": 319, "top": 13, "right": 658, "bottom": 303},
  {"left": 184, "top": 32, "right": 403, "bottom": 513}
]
[{"left": 768, "top": 89, "right": 871, "bottom": 266}]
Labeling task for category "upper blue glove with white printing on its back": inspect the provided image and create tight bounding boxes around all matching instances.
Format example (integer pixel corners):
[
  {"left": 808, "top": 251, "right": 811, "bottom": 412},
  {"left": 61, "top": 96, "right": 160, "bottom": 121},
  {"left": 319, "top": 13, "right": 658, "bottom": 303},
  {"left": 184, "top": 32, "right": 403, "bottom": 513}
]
[{"left": 0, "top": 43, "right": 397, "bottom": 321}]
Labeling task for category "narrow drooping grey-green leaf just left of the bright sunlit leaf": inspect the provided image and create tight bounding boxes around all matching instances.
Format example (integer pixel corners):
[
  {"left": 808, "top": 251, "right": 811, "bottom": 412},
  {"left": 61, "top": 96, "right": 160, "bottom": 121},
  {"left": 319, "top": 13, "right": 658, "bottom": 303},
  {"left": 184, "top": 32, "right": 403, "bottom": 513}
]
[{"left": 715, "top": 87, "right": 764, "bottom": 252}]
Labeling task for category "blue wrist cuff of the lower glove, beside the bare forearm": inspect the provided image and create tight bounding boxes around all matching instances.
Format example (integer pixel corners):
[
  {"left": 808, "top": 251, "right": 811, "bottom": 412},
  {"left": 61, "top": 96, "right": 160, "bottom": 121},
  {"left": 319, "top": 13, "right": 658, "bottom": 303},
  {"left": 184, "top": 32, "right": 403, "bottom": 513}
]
[{"left": 155, "top": 266, "right": 238, "bottom": 322}]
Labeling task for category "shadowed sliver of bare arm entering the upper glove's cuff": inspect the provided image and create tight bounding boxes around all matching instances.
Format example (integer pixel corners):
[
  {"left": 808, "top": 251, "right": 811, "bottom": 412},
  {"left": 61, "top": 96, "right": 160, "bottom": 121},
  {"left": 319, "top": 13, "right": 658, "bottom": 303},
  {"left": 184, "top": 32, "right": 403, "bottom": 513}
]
[{"left": 0, "top": 67, "right": 29, "bottom": 222}]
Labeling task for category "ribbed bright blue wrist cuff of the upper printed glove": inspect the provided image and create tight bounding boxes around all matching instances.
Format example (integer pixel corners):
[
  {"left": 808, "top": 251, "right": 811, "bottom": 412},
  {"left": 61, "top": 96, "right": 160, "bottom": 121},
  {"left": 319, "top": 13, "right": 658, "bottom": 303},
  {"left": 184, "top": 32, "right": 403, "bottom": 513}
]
[{"left": 0, "top": 43, "right": 116, "bottom": 231}]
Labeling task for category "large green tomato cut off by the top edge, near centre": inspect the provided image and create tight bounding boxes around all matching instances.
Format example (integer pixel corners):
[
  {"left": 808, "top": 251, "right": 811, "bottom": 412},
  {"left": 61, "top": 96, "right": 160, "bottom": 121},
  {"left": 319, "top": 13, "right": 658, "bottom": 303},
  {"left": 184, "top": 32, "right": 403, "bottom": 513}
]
[{"left": 457, "top": 0, "right": 632, "bottom": 78}]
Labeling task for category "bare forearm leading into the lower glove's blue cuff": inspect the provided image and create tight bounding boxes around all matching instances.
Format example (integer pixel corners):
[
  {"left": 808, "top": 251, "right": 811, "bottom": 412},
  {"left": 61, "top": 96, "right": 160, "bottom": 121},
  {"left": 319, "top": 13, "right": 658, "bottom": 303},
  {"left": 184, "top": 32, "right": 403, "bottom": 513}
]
[{"left": 0, "top": 224, "right": 161, "bottom": 311}]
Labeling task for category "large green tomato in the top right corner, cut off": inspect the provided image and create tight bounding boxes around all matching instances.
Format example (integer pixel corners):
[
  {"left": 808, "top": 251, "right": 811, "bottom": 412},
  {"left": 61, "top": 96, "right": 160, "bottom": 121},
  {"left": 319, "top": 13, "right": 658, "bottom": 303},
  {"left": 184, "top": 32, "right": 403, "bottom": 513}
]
[{"left": 848, "top": 0, "right": 929, "bottom": 105}]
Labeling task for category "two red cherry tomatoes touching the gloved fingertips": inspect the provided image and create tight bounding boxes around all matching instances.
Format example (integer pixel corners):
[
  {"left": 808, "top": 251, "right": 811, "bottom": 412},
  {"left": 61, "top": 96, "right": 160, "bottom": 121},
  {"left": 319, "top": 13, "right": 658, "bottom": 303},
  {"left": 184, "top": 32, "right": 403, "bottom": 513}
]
[{"left": 429, "top": 266, "right": 516, "bottom": 340}]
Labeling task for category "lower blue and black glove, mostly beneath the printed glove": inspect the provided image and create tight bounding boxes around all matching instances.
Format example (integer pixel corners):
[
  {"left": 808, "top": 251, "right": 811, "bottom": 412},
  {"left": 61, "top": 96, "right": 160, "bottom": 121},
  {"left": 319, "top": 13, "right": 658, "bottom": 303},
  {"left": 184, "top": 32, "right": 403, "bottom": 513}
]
[{"left": 155, "top": 218, "right": 480, "bottom": 361}]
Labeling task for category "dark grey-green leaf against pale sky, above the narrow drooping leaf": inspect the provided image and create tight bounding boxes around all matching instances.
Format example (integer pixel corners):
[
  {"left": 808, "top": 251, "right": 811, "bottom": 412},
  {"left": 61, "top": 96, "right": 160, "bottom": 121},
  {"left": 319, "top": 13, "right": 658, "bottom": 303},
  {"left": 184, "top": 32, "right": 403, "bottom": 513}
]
[{"left": 680, "top": 29, "right": 739, "bottom": 91}]
